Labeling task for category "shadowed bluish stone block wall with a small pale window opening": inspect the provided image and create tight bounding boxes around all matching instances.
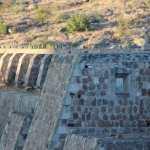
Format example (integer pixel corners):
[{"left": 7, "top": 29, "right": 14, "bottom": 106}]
[{"left": 62, "top": 53, "right": 150, "bottom": 138}]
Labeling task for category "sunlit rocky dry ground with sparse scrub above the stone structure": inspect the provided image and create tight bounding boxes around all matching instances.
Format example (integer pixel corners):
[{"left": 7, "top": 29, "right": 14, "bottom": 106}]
[{"left": 0, "top": 0, "right": 150, "bottom": 48}]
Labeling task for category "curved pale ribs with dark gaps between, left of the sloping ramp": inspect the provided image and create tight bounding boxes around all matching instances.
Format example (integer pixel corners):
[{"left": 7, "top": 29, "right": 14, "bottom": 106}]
[{"left": 0, "top": 50, "right": 51, "bottom": 88}]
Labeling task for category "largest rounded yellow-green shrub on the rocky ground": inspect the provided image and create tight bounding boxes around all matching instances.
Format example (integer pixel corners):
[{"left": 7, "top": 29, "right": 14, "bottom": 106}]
[{"left": 66, "top": 15, "right": 90, "bottom": 33}]
